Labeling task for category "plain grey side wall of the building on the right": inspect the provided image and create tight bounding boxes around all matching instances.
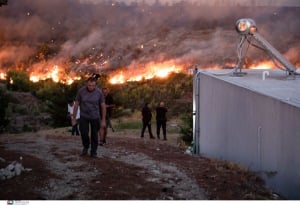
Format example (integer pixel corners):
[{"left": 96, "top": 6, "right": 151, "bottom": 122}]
[{"left": 194, "top": 72, "right": 300, "bottom": 199}]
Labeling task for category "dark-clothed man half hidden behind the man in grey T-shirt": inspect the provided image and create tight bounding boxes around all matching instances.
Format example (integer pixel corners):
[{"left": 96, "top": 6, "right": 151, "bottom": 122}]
[{"left": 99, "top": 88, "right": 115, "bottom": 146}]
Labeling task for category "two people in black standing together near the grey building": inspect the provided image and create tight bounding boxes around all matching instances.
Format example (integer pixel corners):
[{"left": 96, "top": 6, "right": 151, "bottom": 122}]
[{"left": 141, "top": 102, "right": 168, "bottom": 140}]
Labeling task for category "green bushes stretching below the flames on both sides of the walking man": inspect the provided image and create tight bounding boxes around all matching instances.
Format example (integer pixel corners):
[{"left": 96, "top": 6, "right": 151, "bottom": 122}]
[{"left": 1, "top": 71, "right": 192, "bottom": 127}]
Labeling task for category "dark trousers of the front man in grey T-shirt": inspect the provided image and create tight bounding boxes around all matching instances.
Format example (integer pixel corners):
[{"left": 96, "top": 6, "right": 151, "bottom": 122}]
[{"left": 79, "top": 118, "right": 100, "bottom": 154}]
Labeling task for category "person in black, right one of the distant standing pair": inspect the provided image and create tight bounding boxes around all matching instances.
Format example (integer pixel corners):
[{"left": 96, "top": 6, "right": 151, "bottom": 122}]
[{"left": 156, "top": 102, "right": 168, "bottom": 140}]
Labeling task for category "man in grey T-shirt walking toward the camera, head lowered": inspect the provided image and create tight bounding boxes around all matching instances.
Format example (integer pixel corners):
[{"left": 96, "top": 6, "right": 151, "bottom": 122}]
[{"left": 73, "top": 77, "right": 106, "bottom": 158}]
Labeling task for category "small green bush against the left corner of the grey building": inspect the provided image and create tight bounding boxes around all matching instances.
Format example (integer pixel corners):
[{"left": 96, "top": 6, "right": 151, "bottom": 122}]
[{"left": 179, "top": 113, "right": 193, "bottom": 143}]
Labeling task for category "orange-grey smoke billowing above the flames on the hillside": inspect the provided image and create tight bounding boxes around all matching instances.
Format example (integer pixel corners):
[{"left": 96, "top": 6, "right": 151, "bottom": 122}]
[{"left": 0, "top": 0, "right": 300, "bottom": 82}]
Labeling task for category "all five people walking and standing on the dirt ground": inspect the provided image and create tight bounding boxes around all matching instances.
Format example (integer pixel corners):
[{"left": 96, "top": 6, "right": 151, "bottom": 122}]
[{"left": 68, "top": 76, "right": 168, "bottom": 158}]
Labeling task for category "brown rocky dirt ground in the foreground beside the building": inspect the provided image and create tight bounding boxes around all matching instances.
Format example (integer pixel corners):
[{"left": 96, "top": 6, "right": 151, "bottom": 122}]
[{"left": 0, "top": 128, "right": 280, "bottom": 200}]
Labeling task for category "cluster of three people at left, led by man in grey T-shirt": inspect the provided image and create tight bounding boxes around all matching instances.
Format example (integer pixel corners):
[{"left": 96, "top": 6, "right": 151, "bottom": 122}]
[{"left": 69, "top": 77, "right": 114, "bottom": 158}]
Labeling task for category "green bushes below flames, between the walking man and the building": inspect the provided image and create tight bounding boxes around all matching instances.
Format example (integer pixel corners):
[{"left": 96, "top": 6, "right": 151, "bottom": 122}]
[{"left": 111, "top": 73, "right": 193, "bottom": 116}]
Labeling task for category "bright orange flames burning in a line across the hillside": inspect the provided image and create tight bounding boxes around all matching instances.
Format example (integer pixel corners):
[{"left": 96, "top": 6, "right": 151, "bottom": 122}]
[{"left": 0, "top": 58, "right": 300, "bottom": 85}]
